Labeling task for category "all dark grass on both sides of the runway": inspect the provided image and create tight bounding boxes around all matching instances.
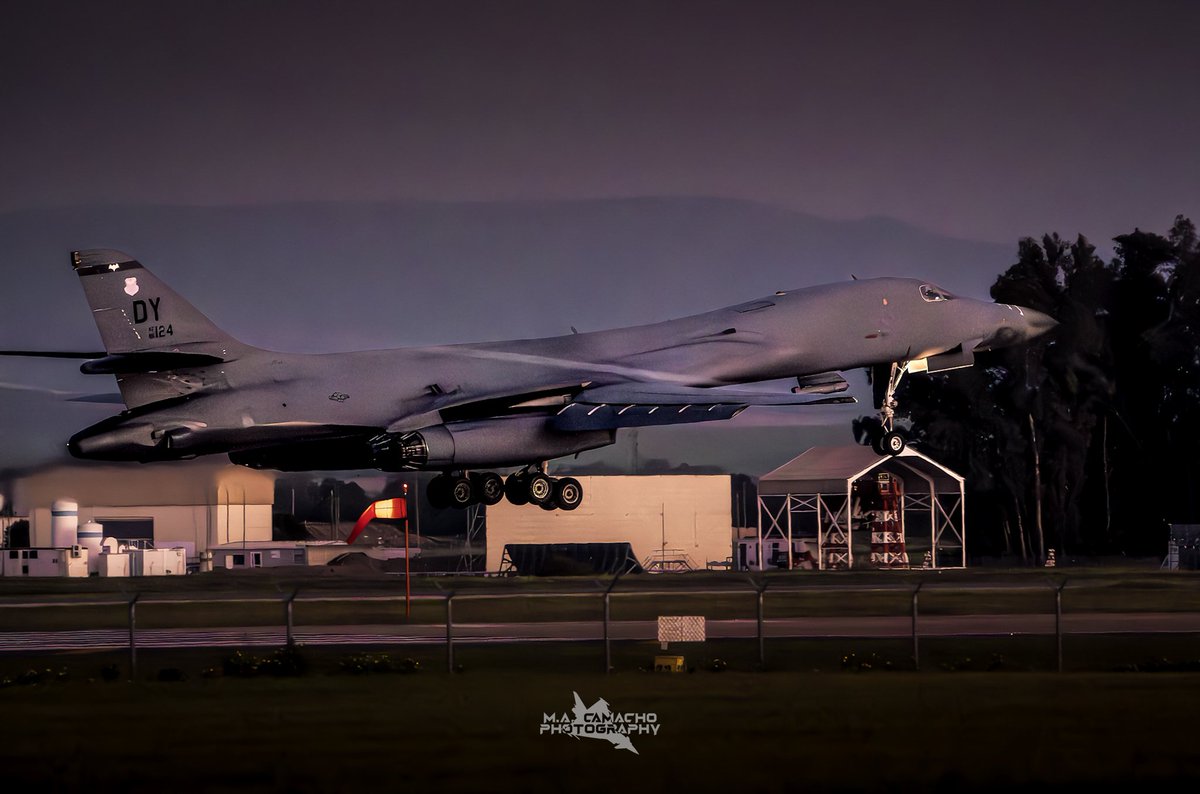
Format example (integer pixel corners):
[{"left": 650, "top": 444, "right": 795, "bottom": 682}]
[{"left": 0, "top": 569, "right": 1200, "bottom": 793}]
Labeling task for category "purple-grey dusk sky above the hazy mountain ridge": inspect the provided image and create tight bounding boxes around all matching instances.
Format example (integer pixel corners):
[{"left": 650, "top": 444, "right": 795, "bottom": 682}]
[{"left": 0, "top": 0, "right": 1200, "bottom": 242}]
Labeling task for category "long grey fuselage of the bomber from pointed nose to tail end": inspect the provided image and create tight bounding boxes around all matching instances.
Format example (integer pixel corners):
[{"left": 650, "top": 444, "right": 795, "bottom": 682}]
[{"left": 63, "top": 263, "right": 1052, "bottom": 468}]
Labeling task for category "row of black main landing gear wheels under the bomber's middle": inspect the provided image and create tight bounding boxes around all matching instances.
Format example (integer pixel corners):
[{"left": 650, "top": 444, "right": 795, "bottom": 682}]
[{"left": 426, "top": 464, "right": 583, "bottom": 510}]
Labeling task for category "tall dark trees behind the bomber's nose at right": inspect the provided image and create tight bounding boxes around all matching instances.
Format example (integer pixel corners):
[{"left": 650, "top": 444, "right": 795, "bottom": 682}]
[{"left": 898, "top": 216, "right": 1200, "bottom": 561}]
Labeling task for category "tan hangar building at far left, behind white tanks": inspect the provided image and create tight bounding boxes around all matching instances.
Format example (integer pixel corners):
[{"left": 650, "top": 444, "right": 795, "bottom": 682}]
[{"left": 4, "top": 461, "right": 275, "bottom": 563}]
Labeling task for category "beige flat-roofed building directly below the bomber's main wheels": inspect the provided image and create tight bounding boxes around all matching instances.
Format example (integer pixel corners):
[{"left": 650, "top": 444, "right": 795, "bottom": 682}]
[{"left": 486, "top": 475, "right": 733, "bottom": 571}]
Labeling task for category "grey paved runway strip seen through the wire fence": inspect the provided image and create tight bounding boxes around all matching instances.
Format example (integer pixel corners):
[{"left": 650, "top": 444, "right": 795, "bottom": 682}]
[{"left": 0, "top": 613, "right": 1200, "bottom": 652}]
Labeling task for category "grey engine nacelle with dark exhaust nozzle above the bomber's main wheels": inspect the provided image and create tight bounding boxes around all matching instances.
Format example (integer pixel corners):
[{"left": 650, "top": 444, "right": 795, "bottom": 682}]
[{"left": 371, "top": 415, "right": 617, "bottom": 471}]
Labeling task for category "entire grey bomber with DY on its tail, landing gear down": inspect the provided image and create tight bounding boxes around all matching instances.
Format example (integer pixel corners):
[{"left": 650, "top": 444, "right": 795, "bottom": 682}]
[{"left": 4, "top": 249, "right": 1055, "bottom": 510}]
